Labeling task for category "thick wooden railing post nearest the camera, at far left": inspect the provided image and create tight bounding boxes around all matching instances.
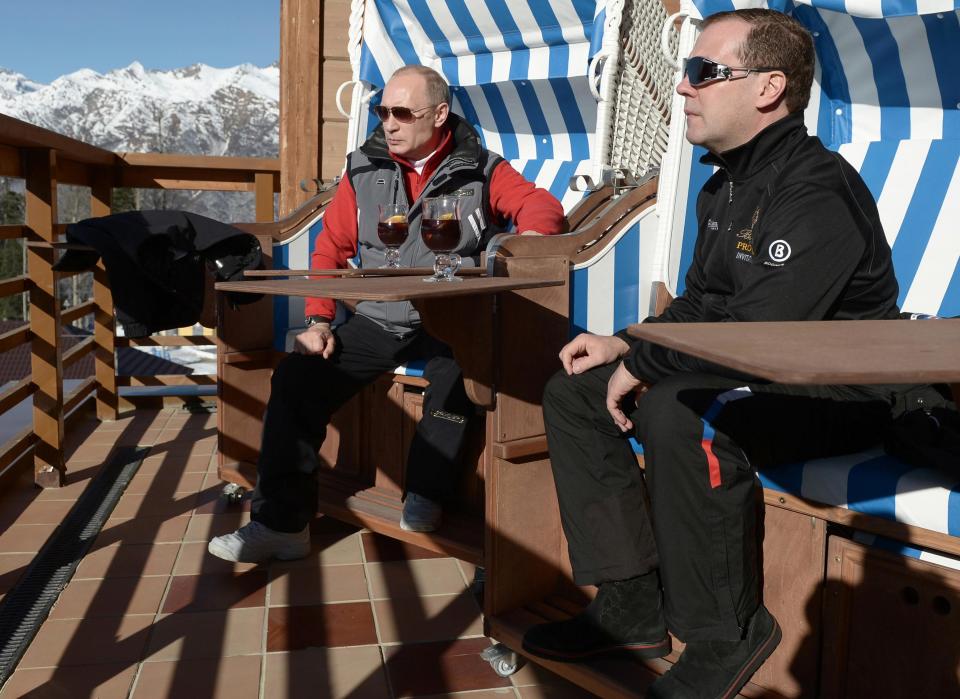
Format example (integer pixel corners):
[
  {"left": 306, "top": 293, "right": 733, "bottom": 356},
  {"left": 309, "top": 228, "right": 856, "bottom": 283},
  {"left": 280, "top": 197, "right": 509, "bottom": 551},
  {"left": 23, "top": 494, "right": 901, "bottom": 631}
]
[{"left": 24, "top": 149, "right": 66, "bottom": 488}]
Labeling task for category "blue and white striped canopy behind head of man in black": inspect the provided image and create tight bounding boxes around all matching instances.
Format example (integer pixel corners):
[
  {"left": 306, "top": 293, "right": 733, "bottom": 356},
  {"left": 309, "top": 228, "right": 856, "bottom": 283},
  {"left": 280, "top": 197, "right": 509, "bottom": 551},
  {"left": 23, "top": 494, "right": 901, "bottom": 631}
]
[{"left": 694, "top": 0, "right": 960, "bottom": 144}]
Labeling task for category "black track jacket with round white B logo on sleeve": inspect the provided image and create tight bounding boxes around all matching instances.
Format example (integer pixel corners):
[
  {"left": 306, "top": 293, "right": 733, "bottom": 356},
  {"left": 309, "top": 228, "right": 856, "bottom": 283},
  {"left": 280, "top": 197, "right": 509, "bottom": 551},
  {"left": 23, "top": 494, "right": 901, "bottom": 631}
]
[{"left": 618, "top": 113, "right": 899, "bottom": 382}]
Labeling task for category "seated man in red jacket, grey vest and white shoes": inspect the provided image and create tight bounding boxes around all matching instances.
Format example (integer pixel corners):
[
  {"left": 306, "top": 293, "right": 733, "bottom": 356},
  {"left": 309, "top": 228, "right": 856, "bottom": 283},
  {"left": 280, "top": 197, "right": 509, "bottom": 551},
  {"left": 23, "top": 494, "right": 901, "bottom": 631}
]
[{"left": 208, "top": 61, "right": 565, "bottom": 562}]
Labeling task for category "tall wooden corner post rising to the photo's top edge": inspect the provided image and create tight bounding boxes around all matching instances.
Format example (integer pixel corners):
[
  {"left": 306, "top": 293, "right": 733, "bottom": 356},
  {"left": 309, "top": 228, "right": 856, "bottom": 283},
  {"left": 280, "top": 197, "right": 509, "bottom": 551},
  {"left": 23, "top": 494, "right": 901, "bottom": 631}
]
[{"left": 280, "top": 0, "right": 322, "bottom": 218}]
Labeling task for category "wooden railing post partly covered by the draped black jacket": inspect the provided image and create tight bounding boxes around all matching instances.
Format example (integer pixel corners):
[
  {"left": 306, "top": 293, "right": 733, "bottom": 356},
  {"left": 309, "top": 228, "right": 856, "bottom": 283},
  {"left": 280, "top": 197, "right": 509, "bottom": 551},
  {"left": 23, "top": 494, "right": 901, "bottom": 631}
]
[{"left": 90, "top": 169, "right": 120, "bottom": 420}]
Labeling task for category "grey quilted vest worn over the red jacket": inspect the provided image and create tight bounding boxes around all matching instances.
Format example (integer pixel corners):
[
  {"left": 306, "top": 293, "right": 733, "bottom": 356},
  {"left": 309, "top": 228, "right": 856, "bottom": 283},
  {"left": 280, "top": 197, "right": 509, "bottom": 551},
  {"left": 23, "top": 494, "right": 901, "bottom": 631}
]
[{"left": 347, "top": 114, "right": 506, "bottom": 335}]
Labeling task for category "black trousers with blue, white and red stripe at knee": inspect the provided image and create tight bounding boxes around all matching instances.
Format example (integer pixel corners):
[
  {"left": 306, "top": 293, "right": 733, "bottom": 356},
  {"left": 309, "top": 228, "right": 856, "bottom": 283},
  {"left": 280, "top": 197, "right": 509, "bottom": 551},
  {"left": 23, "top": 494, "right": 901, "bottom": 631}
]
[{"left": 543, "top": 364, "right": 891, "bottom": 641}]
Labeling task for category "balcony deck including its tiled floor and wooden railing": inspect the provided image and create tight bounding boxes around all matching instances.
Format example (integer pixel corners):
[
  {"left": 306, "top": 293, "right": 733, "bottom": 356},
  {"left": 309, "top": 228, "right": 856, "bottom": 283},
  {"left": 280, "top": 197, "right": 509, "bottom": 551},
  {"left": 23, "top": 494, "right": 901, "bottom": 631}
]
[{"left": 0, "top": 110, "right": 591, "bottom": 699}]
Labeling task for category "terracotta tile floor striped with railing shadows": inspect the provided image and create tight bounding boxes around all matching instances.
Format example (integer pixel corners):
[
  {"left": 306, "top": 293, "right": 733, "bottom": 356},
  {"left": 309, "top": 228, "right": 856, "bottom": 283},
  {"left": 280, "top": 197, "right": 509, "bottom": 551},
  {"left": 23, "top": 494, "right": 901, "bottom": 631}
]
[{"left": 0, "top": 409, "right": 590, "bottom": 699}]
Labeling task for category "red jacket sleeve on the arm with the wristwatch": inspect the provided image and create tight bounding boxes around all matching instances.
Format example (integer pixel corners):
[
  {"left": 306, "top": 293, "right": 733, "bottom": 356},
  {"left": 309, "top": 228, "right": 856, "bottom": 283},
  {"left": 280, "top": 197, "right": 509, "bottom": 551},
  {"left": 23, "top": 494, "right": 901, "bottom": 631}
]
[{"left": 304, "top": 177, "right": 357, "bottom": 318}]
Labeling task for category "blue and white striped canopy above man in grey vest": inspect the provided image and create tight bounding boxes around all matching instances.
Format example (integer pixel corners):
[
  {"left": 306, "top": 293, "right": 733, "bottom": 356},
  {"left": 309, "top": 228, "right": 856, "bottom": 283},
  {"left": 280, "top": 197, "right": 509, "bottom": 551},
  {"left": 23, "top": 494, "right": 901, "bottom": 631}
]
[{"left": 351, "top": 0, "right": 606, "bottom": 207}]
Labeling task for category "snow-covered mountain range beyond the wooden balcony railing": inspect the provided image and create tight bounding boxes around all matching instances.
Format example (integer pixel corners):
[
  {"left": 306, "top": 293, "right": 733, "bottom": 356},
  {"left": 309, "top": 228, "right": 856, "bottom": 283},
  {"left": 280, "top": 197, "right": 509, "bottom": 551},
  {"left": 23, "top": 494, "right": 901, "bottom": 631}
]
[{"left": 0, "top": 62, "right": 280, "bottom": 221}]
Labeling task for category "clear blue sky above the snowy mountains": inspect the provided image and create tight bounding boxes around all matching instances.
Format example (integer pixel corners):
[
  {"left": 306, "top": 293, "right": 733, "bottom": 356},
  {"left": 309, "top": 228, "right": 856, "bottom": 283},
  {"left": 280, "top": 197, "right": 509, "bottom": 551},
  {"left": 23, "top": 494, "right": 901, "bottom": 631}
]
[{"left": 0, "top": 0, "right": 280, "bottom": 83}]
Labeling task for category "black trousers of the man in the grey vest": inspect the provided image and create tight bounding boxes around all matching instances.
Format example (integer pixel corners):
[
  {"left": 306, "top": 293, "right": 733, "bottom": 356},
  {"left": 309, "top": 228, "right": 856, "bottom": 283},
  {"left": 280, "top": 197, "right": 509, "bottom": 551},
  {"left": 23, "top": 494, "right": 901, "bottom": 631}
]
[{"left": 251, "top": 315, "right": 474, "bottom": 532}]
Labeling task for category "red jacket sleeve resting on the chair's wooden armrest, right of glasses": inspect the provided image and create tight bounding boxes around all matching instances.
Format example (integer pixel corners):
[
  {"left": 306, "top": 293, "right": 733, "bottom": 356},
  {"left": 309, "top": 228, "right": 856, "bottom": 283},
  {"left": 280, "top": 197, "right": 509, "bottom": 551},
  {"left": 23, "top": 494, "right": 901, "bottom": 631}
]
[{"left": 490, "top": 160, "right": 566, "bottom": 235}]
